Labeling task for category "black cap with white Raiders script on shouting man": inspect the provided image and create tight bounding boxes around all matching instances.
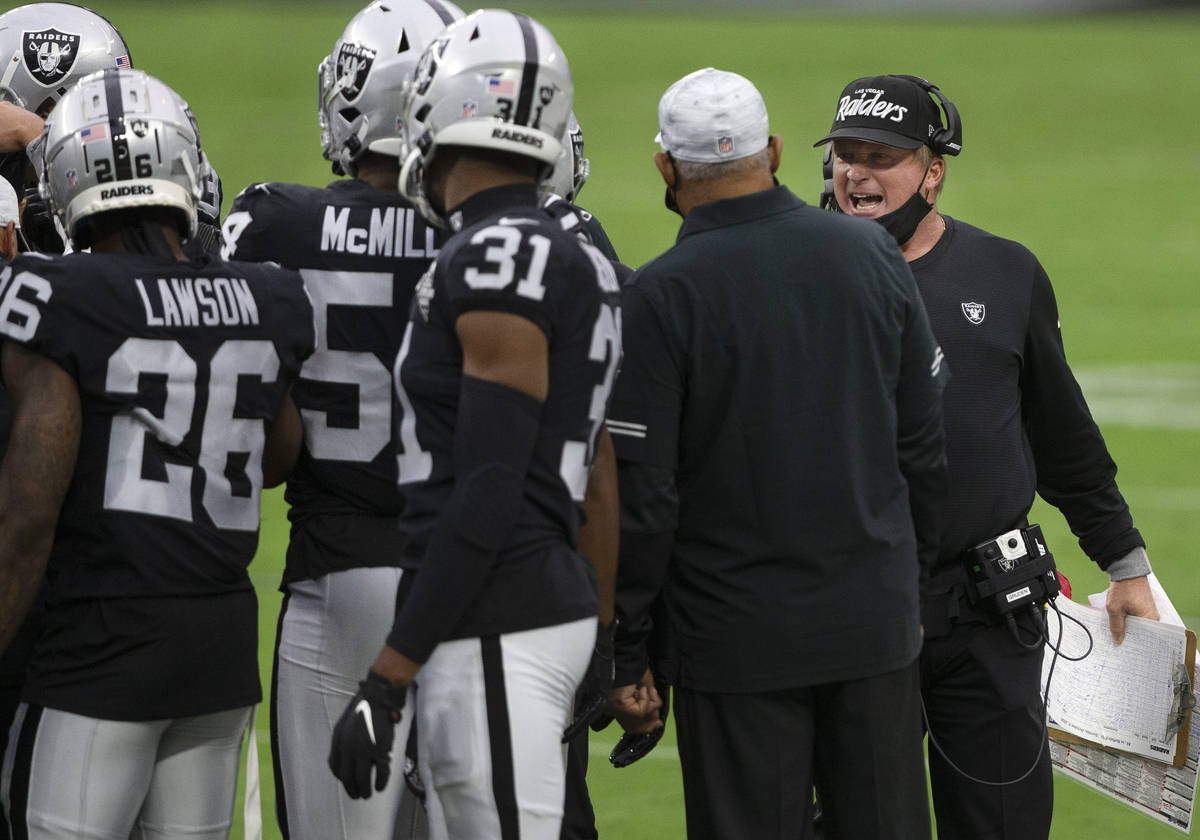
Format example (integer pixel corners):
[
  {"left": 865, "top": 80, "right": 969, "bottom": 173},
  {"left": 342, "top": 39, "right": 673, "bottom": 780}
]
[{"left": 812, "top": 76, "right": 942, "bottom": 149}]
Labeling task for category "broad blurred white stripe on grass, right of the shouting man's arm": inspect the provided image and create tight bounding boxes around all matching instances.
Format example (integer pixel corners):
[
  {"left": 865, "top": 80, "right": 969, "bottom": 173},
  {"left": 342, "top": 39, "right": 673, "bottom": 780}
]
[{"left": 1075, "top": 362, "right": 1200, "bottom": 431}]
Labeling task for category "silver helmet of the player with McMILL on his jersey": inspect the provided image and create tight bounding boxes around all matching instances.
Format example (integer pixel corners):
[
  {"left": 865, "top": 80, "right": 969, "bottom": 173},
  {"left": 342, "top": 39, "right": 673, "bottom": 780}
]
[{"left": 317, "top": 0, "right": 462, "bottom": 175}]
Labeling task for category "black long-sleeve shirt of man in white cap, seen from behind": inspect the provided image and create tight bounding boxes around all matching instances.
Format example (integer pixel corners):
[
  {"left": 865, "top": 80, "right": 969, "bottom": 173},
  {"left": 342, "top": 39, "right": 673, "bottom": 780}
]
[{"left": 608, "top": 187, "right": 946, "bottom": 691}]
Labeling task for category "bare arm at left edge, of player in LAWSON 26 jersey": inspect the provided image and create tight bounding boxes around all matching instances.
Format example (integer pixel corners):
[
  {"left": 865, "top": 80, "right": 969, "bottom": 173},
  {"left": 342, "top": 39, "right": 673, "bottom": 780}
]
[{"left": 0, "top": 342, "right": 80, "bottom": 652}]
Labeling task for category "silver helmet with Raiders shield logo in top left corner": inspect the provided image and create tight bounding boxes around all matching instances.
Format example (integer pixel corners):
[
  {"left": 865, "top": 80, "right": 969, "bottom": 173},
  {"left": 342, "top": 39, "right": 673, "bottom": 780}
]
[{"left": 0, "top": 2, "right": 133, "bottom": 116}]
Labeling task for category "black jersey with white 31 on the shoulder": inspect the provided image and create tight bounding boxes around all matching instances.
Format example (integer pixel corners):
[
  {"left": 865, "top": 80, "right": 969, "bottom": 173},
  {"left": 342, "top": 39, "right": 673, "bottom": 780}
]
[{"left": 396, "top": 186, "right": 620, "bottom": 637}]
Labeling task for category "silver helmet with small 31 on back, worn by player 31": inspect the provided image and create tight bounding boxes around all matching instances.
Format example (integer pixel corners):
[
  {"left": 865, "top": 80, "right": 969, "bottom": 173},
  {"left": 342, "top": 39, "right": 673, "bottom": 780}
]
[{"left": 400, "top": 8, "right": 575, "bottom": 227}]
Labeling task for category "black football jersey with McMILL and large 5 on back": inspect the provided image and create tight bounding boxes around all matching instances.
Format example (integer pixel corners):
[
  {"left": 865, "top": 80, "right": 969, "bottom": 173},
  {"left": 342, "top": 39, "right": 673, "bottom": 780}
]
[{"left": 224, "top": 180, "right": 440, "bottom": 582}]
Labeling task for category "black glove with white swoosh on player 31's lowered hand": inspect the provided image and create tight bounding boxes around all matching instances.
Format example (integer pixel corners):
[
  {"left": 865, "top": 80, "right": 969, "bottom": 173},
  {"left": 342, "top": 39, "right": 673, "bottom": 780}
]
[{"left": 329, "top": 671, "right": 408, "bottom": 799}]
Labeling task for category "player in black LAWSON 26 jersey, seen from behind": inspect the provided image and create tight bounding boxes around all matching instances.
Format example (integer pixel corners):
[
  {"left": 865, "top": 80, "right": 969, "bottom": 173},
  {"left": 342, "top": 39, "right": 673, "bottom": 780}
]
[{"left": 0, "top": 68, "right": 316, "bottom": 839}]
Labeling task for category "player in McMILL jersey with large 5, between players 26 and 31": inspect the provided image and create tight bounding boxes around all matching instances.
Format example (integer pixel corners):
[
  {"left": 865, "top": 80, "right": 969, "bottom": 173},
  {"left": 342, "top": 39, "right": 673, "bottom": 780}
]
[{"left": 223, "top": 0, "right": 462, "bottom": 840}]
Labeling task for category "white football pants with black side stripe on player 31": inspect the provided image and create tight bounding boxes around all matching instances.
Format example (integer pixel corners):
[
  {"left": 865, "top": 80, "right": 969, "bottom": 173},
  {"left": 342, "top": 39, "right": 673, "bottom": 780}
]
[{"left": 416, "top": 618, "right": 596, "bottom": 840}]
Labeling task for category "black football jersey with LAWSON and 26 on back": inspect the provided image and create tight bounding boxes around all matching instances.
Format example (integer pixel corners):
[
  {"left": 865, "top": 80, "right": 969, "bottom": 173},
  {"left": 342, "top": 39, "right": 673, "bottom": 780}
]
[{"left": 0, "top": 253, "right": 314, "bottom": 601}]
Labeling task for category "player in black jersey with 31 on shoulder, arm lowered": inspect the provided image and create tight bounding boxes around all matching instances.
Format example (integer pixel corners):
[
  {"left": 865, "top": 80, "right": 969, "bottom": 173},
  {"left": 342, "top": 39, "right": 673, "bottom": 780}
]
[{"left": 330, "top": 10, "right": 620, "bottom": 840}]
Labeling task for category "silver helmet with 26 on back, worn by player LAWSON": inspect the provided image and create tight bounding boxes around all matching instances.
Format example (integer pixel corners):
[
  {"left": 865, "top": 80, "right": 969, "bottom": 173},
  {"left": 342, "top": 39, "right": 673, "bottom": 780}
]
[{"left": 41, "top": 70, "right": 203, "bottom": 250}]
